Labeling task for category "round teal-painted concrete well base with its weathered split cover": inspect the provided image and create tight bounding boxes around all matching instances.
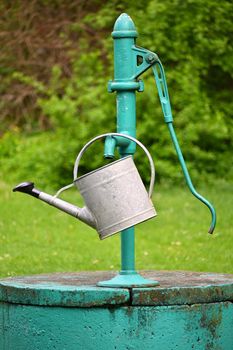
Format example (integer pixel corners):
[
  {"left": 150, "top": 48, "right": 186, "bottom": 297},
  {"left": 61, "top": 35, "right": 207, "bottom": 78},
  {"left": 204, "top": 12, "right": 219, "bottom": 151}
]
[{"left": 0, "top": 271, "right": 233, "bottom": 350}]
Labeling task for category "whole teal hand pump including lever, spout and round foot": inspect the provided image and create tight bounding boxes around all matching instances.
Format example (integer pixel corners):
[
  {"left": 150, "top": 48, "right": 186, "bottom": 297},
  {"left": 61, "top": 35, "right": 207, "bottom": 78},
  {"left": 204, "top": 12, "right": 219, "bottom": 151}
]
[{"left": 100, "top": 13, "right": 216, "bottom": 286}]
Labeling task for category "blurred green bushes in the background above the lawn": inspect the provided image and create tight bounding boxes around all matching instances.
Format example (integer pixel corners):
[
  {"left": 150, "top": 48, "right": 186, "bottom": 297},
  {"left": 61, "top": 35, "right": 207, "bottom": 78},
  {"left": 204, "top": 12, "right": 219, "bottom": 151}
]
[{"left": 0, "top": 0, "right": 233, "bottom": 188}]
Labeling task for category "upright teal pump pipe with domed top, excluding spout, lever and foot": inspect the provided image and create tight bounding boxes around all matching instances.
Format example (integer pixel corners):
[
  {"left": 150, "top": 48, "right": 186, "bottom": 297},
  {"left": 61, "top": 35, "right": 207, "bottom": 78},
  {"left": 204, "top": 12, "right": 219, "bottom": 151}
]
[{"left": 109, "top": 13, "right": 138, "bottom": 274}]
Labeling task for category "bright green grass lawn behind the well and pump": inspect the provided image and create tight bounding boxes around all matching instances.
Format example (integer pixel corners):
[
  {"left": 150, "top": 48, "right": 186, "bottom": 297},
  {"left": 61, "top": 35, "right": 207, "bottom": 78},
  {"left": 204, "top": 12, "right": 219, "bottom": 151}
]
[{"left": 0, "top": 182, "right": 233, "bottom": 277}]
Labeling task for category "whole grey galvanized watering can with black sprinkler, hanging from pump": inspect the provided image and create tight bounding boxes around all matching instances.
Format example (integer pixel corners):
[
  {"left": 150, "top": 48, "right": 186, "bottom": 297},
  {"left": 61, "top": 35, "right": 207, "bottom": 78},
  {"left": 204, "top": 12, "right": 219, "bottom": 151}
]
[{"left": 13, "top": 133, "right": 157, "bottom": 239}]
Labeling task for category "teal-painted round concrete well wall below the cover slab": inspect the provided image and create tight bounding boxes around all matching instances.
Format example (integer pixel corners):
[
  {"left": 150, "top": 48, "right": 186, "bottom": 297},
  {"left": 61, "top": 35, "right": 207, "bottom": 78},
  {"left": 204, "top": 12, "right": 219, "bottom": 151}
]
[{"left": 0, "top": 302, "right": 233, "bottom": 350}]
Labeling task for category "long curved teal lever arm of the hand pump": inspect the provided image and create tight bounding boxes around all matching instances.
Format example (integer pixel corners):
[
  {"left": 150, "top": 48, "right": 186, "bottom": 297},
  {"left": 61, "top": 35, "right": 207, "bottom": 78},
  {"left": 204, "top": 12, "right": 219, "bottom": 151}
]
[{"left": 152, "top": 58, "right": 216, "bottom": 233}]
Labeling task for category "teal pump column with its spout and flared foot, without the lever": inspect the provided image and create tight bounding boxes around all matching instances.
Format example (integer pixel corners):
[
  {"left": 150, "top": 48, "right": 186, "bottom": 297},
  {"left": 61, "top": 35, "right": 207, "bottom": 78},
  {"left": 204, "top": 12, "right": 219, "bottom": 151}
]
[{"left": 98, "top": 13, "right": 158, "bottom": 287}]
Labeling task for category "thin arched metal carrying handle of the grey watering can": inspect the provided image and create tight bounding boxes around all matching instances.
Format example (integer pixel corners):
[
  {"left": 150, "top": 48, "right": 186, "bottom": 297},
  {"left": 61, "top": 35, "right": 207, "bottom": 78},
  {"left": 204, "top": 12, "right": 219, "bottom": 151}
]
[{"left": 73, "top": 132, "right": 155, "bottom": 198}]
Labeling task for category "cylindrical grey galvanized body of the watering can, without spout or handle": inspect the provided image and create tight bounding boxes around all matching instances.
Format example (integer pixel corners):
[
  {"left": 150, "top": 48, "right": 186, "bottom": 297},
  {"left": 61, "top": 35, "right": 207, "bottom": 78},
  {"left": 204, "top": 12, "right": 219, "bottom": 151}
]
[{"left": 75, "top": 156, "right": 156, "bottom": 239}]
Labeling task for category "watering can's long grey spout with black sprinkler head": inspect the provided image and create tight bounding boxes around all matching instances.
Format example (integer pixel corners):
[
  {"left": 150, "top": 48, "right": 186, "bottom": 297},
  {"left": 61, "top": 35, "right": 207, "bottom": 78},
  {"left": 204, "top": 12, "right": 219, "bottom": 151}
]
[{"left": 13, "top": 182, "right": 96, "bottom": 229}]
